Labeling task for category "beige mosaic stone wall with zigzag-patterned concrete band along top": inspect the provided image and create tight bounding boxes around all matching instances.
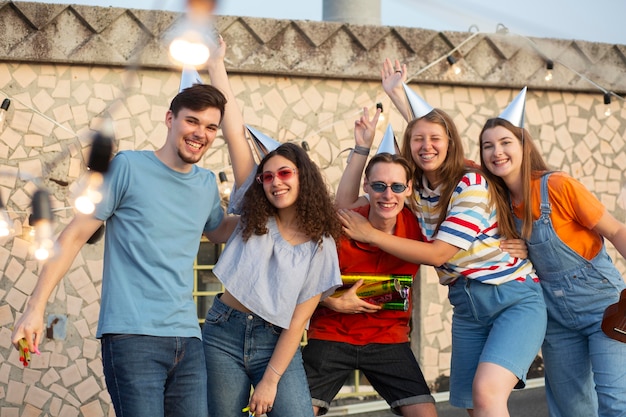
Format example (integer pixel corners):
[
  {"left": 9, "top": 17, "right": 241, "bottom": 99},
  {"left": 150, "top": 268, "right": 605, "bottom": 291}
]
[{"left": 0, "top": 1, "right": 626, "bottom": 417}]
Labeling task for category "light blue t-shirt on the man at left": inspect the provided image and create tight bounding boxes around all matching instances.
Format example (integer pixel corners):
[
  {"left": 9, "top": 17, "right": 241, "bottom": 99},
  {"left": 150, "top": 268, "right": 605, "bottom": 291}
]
[{"left": 95, "top": 151, "right": 224, "bottom": 338}]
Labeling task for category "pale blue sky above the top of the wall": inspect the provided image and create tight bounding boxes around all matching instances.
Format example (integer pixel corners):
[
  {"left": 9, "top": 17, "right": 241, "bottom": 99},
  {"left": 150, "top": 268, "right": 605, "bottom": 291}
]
[{"left": 24, "top": 0, "right": 626, "bottom": 45}]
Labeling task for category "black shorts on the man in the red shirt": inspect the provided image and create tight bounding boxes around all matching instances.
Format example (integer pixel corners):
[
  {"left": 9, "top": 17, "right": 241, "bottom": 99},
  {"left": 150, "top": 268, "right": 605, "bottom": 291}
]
[{"left": 302, "top": 339, "right": 435, "bottom": 415}]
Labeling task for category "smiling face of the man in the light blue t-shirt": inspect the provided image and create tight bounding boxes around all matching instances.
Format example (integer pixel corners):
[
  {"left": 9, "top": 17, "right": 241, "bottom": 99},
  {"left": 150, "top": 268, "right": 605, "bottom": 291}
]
[{"left": 165, "top": 107, "right": 221, "bottom": 169}]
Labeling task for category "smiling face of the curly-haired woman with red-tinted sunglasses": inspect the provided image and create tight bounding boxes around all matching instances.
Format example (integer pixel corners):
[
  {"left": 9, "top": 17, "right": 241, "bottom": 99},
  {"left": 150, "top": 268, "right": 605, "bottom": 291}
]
[{"left": 262, "top": 155, "right": 300, "bottom": 210}]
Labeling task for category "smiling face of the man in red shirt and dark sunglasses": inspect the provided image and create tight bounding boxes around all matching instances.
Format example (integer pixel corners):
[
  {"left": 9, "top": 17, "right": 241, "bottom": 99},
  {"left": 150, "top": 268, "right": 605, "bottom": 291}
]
[{"left": 363, "top": 162, "right": 412, "bottom": 228}]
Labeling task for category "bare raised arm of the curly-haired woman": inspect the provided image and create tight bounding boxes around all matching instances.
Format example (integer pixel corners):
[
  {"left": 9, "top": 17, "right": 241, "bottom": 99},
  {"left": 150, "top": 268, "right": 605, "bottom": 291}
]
[{"left": 207, "top": 36, "right": 255, "bottom": 185}]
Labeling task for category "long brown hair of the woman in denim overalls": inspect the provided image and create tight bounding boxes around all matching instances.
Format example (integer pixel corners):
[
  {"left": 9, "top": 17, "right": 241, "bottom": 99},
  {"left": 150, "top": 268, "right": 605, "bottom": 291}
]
[{"left": 479, "top": 117, "right": 549, "bottom": 239}]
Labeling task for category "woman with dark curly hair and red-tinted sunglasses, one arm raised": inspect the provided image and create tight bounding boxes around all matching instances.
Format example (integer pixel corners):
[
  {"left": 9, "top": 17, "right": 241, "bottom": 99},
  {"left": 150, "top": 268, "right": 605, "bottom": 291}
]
[{"left": 203, "top": 38, "right": 341, "bottom": 417}]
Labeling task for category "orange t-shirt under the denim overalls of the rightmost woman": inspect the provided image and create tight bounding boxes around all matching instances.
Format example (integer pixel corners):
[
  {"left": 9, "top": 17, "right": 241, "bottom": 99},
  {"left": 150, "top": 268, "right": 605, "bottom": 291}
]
[{"left": 513, "top": 172, "right": 606, "bottom": 260}]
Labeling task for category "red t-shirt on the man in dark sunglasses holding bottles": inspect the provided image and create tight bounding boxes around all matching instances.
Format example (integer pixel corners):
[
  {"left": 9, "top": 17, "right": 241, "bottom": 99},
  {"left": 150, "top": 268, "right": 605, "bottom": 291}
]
[{"left": 307, "top": 205, "right": 423, "bottom": 345}]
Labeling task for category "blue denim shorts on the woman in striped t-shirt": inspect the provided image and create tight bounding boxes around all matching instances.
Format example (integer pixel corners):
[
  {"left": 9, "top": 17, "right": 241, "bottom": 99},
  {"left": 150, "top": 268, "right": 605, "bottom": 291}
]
[{"left": 448, "top": 277, "right": 547, "bottom": 409}]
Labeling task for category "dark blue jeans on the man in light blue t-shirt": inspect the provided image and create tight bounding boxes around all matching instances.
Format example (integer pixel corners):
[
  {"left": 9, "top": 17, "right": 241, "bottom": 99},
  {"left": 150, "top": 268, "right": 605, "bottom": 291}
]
[{"left": 101, "top": 334, "right": 208, "bottom": 417}]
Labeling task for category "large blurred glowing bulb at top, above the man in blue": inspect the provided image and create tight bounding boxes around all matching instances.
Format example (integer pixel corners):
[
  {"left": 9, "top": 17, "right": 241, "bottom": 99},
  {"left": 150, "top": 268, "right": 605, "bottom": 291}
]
[{"left": 169, "top": 0, "right": 215, "bottom": 67}]
